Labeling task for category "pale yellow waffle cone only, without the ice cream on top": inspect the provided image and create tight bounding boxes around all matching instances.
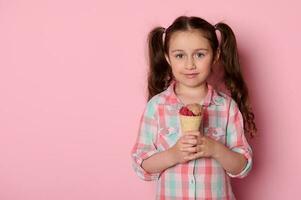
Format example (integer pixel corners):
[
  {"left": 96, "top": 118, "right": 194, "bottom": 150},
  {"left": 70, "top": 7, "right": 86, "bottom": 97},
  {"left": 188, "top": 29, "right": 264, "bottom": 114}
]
[{"left": 180, "top": 115, "right": 202, "bottom": 132}]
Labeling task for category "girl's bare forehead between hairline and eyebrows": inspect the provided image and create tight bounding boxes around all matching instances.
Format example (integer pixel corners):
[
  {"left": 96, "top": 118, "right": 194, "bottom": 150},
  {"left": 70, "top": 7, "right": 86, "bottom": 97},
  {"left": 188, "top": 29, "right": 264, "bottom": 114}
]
[{"left": 169, "top": 30, "right": 210, "bottom": 50}]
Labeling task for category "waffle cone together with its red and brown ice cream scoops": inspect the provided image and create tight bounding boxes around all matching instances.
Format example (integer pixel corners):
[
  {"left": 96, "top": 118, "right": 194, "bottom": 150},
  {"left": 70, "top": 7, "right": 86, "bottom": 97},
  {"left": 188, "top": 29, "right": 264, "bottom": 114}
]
[{"left": 180, "top": 104, "right": 202, "bottom": 134}]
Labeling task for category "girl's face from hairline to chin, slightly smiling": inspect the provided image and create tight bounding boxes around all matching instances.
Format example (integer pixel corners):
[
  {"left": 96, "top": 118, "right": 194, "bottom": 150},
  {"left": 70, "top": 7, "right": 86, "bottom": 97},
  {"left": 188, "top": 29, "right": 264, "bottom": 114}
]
[{"left": 165, "top": 30, "right": 215, "bottom": 87}]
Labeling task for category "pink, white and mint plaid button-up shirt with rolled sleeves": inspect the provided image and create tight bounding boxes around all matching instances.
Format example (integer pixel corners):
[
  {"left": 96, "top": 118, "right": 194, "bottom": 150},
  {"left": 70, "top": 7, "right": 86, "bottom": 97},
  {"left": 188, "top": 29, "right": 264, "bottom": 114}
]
[{"left": 131, "top": 82, "right": 252, "bottom": 200}]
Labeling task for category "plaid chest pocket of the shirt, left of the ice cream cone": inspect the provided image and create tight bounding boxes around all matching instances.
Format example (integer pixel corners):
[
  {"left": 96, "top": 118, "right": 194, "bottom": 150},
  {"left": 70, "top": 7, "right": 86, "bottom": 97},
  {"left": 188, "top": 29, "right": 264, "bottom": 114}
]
[{"left": 157, "top": 127, "right": 179, "bottom": 151}]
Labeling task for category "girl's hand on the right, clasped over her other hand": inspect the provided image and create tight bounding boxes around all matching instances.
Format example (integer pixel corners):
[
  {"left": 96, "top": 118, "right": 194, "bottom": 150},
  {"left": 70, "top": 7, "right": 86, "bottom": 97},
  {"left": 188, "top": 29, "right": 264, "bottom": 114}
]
[{"left": 184, "top": 136, "right": 221, "bottom": 160}]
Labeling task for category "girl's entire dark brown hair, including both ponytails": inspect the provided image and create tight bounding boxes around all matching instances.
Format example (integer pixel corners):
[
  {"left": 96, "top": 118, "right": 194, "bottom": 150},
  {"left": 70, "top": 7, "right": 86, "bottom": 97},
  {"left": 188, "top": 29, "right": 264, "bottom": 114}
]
[{"left": 148, "top": 16, "right": 257, "bottom": 137}]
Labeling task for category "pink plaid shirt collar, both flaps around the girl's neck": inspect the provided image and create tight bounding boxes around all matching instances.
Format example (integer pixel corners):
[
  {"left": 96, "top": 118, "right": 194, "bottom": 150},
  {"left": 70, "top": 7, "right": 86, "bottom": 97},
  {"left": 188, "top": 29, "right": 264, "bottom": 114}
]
[{"left": 162, "top": 81, "right": 222, "bottom": 107}]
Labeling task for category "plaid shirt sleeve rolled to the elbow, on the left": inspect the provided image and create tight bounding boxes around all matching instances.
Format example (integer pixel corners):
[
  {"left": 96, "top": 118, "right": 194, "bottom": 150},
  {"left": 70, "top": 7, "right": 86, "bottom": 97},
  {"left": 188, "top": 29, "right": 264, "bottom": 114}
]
[{"left": 131, "top": 102, "right": 160, "bottom": 181}]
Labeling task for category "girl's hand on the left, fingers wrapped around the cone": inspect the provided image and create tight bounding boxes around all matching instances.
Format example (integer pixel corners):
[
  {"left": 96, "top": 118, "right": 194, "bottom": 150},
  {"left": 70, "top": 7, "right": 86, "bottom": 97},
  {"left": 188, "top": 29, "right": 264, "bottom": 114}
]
[{"left": 171, "top": 132, "right": 200, "bottom": 163}]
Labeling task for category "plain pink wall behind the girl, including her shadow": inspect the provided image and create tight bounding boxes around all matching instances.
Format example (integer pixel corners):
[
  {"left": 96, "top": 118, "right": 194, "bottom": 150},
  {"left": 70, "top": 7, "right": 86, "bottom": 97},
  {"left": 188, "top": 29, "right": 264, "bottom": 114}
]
[{"left": 0, "top": 0, "right": 301, "bottom": 200}]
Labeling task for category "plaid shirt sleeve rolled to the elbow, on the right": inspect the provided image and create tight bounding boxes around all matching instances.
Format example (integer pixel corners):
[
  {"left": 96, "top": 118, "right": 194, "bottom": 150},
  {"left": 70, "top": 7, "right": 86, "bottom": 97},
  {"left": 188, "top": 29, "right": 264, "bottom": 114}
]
[{"left": 226, "top": 100, "right": 253, "bottom": 178}]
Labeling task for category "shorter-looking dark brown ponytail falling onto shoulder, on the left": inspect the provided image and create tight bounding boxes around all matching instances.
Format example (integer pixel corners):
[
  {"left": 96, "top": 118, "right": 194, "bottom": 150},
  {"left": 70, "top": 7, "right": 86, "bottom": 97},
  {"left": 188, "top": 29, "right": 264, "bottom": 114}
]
[{"left": 148, "top": 27, "right": 172, "bottom": 100}]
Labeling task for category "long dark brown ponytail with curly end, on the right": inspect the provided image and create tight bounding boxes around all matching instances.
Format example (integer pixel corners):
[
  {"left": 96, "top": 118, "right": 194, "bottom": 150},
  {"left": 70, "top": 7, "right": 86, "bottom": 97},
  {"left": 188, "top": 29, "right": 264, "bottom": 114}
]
[{"left": 215, "top": 23, "right": 257, "bottom": 137}]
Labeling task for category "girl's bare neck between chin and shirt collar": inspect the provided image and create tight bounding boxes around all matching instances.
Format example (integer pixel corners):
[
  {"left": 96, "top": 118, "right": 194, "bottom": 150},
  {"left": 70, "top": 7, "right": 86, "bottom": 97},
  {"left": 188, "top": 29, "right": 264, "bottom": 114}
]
[{"left": 175, "top": 82, "right": 208, "bottom": 105}]
